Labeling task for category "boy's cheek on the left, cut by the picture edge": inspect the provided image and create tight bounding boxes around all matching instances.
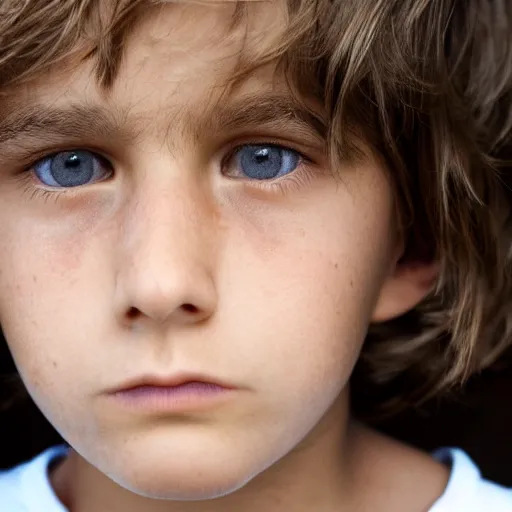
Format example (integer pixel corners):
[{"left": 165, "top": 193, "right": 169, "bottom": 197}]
[{"left": 0, "top": 202, "right": 108, "bottom": 410}]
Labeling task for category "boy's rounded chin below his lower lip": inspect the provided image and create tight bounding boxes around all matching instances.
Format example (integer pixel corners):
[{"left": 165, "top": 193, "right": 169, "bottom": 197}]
[{"left": 82, "top": 428, "right": 284, "bottom": 501}]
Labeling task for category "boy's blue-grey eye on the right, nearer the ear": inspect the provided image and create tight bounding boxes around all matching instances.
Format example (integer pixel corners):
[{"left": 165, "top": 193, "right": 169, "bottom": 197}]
[{"left": 234, "top": 144, "right": 301, "bottom": 180}]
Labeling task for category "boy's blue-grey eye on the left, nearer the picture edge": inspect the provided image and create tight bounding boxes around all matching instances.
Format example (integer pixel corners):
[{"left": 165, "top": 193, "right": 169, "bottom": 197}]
[{"left": 33, "top": 150, "right": 112, "bottom": 188}]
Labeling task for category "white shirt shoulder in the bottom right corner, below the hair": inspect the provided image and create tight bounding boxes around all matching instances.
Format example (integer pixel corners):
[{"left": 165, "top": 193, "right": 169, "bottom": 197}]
[{"left": 430, "top": 448, "right": 512, "bottom": 512}]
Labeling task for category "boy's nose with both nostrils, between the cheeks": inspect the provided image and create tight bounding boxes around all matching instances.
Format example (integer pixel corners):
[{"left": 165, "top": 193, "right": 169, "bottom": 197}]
[{"left": 115, "top": 173, "right": 217, "bottom": 326}]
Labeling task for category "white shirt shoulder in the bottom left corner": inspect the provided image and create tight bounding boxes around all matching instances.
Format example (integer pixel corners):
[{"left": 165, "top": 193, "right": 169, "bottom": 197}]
[{"left": 0, "top": 446, "right": 67, "bottom": 512}]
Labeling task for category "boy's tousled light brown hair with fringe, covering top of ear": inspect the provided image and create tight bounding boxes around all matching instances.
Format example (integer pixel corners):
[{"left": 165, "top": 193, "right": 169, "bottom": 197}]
[{"left": 0, "top": 0, "right": 512, "bottom": 416}]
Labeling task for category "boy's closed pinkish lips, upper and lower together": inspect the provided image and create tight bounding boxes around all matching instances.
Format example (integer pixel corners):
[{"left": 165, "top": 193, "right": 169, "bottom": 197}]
[{"left": 108, "top": 373, "right": 237, "bottom": 414}]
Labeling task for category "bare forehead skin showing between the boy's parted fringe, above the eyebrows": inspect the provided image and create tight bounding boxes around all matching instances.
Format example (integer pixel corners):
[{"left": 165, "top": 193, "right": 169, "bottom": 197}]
[{"left": 114, "top": 2, "right": 285, "bottom": 101}]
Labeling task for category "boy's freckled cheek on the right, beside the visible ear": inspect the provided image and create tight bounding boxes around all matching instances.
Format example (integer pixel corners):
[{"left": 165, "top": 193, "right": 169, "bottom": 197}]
[{"left": 220, "top": 173, "right": 393, "bottom": 410}]
